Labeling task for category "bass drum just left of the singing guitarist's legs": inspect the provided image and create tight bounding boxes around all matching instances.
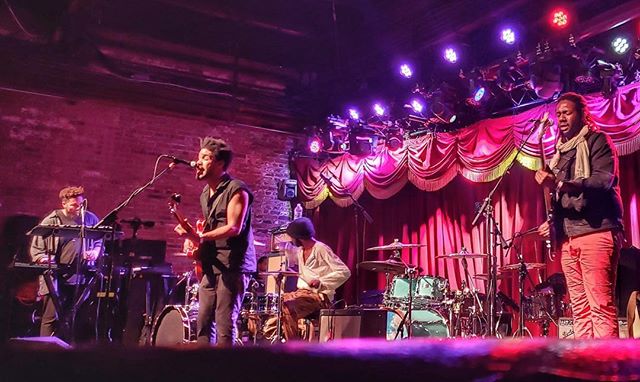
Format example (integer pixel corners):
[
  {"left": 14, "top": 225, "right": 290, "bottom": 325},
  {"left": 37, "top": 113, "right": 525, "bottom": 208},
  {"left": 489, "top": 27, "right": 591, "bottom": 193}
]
[{"left": 151, "top": 305, "right": 198, "bottom": 346}]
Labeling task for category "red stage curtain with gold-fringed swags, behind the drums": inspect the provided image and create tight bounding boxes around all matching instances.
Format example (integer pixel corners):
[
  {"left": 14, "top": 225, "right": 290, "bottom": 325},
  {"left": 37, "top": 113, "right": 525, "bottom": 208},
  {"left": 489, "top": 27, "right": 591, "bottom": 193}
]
[{"left": 294, "top": 84, "right": 640, "bottom": 303}]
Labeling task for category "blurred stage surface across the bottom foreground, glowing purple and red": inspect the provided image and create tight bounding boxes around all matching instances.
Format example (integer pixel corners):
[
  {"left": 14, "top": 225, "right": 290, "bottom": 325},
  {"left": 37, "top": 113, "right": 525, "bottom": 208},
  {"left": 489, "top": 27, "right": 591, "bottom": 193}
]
[{"left": 5, "top": 339, "right": 640, "bottom": 382}]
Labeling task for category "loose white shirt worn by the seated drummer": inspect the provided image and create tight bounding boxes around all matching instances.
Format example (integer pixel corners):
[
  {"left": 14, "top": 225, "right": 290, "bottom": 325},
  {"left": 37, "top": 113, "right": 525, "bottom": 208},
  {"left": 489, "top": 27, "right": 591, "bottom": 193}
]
[{"left": 285, "top": 241, "right": 351, "bottom": 300}]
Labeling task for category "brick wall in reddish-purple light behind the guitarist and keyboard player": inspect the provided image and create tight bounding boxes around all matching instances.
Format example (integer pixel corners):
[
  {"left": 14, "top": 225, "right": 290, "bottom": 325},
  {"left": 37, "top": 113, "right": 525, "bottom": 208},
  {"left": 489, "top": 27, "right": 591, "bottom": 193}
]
[{"left": 0, "top": 90, "right": 296, "bottom": 271}]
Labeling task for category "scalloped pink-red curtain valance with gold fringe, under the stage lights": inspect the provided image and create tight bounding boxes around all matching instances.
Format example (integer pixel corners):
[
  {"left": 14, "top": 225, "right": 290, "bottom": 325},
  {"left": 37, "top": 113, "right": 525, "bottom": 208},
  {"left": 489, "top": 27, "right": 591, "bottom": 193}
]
[{"left": 293, "top": 83, "right": 640, "bottom": 208}]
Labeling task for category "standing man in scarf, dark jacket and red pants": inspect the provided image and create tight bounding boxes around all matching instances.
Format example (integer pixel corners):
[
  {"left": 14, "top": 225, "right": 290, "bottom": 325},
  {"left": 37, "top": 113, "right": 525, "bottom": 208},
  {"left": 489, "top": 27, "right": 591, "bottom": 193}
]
[{"left": 535, "top": 93, "right": 622, "bottom": 338}]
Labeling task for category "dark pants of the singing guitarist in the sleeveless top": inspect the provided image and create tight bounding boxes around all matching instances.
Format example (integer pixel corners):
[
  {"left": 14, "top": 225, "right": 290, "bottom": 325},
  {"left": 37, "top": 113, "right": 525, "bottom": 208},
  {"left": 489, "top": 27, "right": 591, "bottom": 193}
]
[{"left": 198, "top": 272, "right": 250, "bottom": 346}]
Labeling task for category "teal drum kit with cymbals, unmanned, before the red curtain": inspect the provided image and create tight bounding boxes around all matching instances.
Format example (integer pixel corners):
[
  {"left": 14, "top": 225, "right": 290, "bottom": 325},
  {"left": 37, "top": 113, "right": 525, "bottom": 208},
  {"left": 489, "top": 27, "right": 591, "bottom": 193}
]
[{"left": 358, "top": 239, "right": 566, "bottom": 339}]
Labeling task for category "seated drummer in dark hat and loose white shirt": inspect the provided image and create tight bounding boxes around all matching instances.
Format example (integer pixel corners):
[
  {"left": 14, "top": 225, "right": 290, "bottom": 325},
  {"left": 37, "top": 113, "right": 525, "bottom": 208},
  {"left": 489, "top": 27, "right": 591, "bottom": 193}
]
[{"left": 265, "top": 218, "right": 351, "bottom": 340}]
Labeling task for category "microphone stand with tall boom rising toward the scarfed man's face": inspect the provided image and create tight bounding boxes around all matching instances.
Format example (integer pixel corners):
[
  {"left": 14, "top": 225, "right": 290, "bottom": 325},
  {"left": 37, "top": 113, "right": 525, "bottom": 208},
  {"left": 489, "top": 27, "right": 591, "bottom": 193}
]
[{"left": 471, "top": 120, "right": 537, "bottom": 337}]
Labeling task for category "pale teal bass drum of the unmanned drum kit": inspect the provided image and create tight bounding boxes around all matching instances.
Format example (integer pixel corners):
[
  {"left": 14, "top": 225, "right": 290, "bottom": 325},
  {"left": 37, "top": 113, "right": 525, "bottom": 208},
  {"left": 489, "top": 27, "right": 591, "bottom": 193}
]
[{"left": 387, "top": 309, "right": 449, "bottom": 340}]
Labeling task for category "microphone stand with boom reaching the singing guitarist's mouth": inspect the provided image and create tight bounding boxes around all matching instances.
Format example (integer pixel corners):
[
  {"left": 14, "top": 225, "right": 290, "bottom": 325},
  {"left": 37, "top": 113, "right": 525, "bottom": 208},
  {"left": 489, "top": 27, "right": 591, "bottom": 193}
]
[{"left": 96, "top": 155, "right": 175, "bottom": 340}]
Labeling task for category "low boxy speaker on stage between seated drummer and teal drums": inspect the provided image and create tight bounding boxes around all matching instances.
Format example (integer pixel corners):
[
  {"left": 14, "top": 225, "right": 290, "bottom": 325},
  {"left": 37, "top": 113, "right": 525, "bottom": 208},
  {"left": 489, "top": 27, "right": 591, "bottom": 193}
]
[{"left": 320, "top": 308, "right": 393, "bottom": 342}]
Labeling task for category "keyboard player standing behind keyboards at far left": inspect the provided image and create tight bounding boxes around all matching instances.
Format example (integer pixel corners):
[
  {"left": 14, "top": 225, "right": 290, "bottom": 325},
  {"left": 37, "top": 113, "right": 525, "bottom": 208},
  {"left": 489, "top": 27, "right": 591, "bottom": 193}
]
[{"left": 29, "top": 186, "right": 103, "bottom": 336}]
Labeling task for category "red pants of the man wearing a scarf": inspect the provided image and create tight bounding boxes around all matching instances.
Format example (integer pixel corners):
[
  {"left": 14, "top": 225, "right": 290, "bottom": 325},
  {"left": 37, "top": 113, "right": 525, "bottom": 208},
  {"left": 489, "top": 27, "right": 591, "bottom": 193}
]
[{"left": 562, "top": 231, "right": 620, "bottom": 338}]
